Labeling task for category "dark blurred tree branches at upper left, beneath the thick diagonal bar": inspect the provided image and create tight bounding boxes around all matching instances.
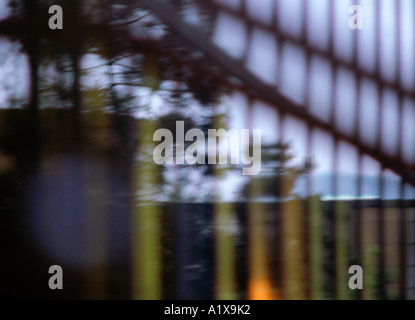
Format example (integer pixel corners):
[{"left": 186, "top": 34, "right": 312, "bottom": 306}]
[{"left": 4, "top": 0, "right": 227, "bottom": 112}]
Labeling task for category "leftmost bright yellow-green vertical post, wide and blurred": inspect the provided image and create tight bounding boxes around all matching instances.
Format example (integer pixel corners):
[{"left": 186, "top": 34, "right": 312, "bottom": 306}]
[{"left": 132, "top": 119, "right": 162, "bottom": 300}]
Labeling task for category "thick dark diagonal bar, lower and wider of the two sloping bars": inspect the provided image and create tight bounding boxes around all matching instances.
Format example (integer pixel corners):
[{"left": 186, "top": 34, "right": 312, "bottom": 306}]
[{"left": 140, "top": 0, "right": 415, "bottom": 186}]
